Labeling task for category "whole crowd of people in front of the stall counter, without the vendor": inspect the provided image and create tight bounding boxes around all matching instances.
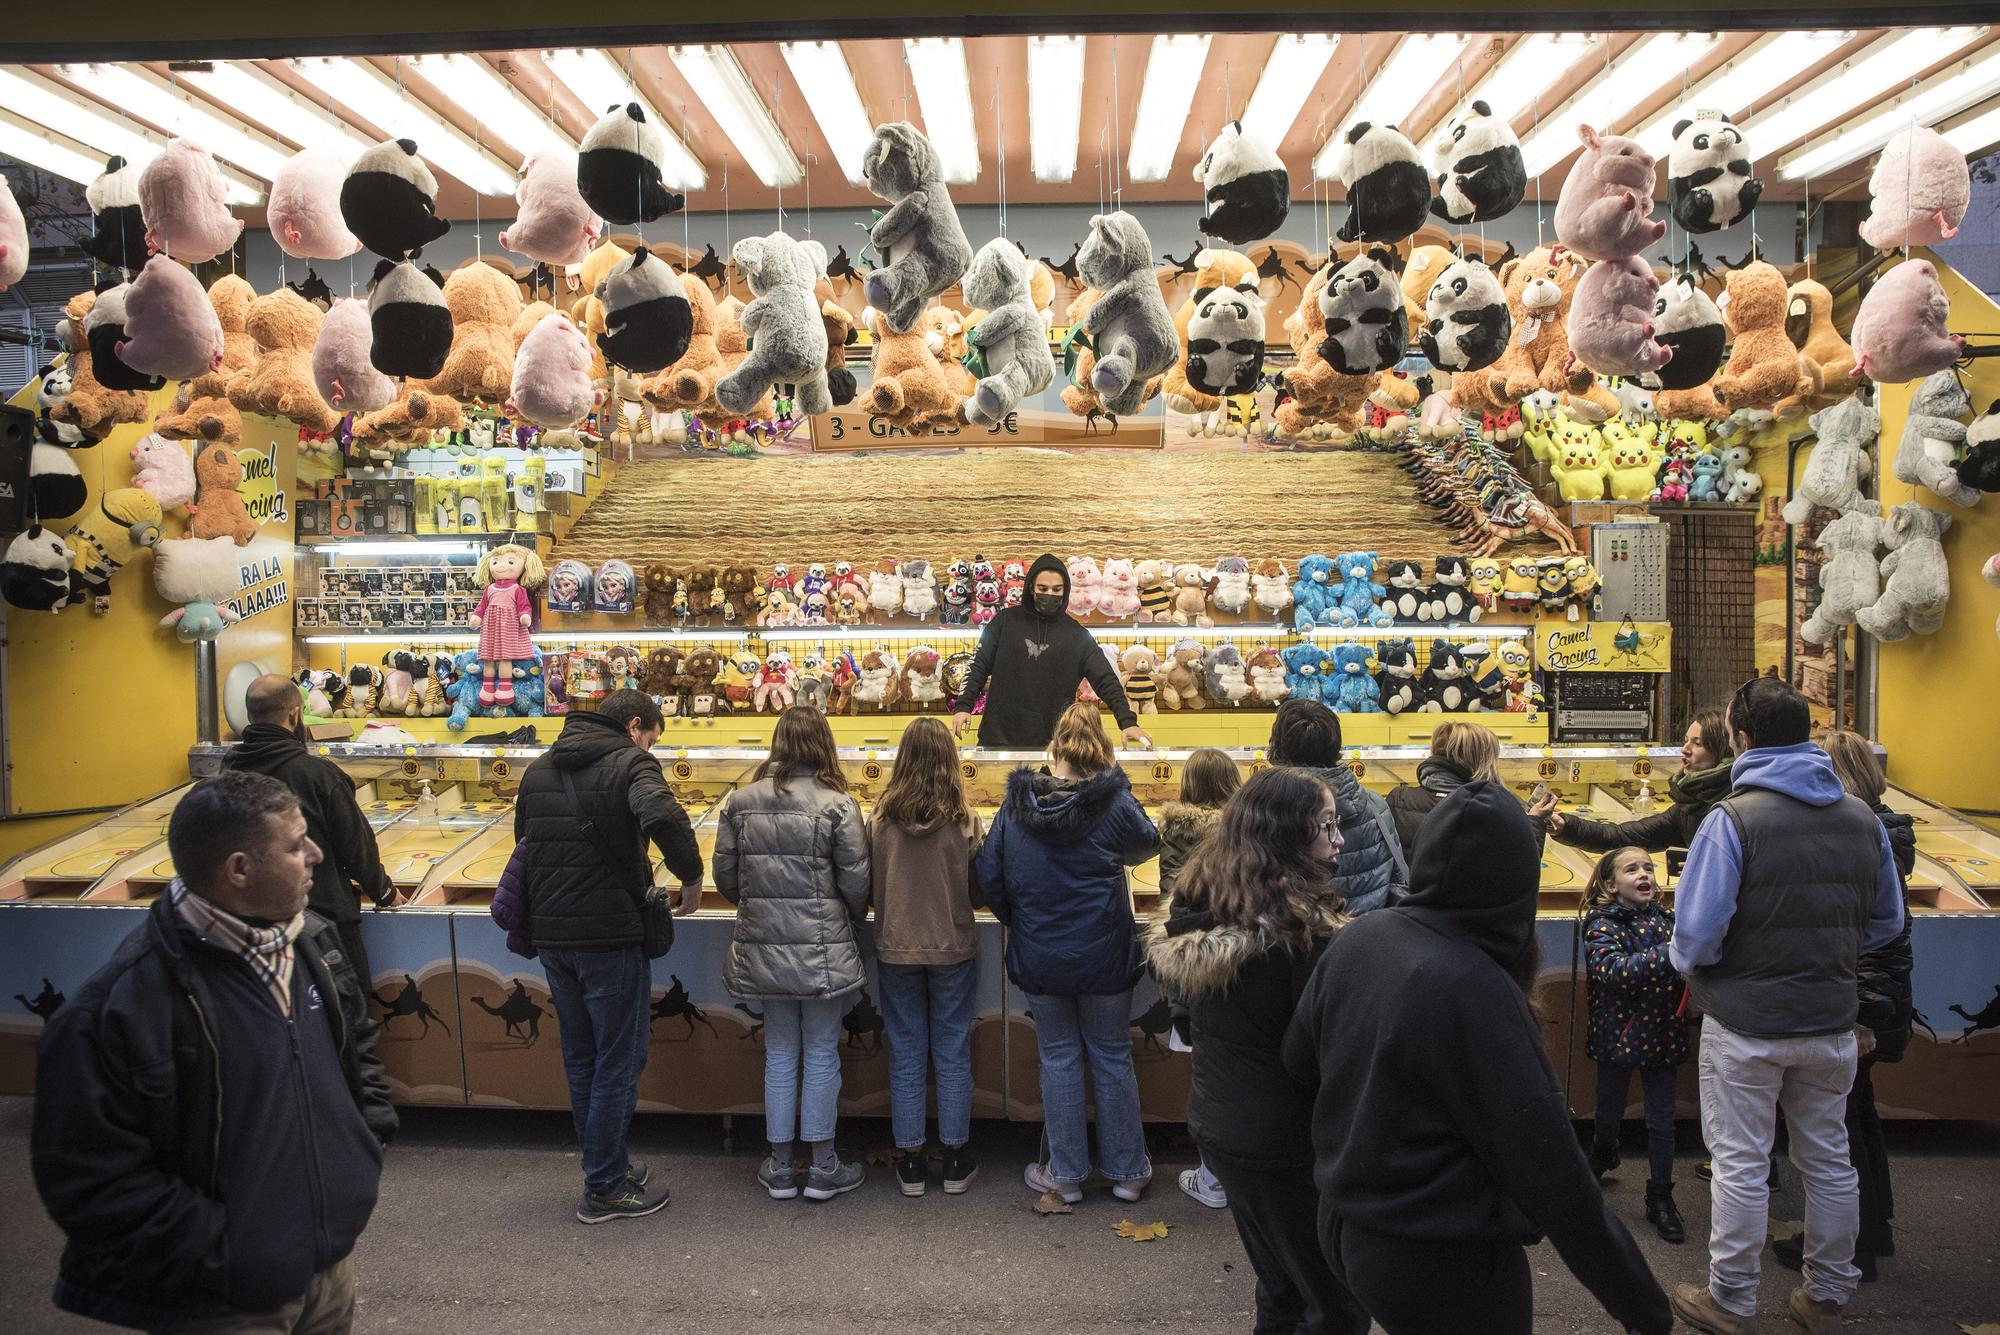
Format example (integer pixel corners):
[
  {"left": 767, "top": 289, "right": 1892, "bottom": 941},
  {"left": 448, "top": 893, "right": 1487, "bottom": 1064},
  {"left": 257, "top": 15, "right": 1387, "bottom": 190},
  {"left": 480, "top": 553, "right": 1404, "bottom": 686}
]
[{"left": 23, "top": 677, "right": 1912, "bottom": 1335}]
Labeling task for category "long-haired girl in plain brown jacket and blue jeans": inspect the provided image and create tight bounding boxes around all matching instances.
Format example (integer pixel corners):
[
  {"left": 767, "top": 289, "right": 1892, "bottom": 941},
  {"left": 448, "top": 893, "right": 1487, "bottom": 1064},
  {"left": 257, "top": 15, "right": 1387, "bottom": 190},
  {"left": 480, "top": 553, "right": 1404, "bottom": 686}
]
[{"left": 868, "top": 717, "right": 980, "bottom": 1195}]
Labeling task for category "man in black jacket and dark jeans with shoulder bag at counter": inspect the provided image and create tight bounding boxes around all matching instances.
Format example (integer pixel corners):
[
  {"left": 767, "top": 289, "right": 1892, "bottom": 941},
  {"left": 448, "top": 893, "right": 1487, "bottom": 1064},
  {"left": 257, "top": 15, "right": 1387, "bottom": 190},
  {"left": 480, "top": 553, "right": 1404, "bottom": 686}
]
[{"left": 514, "top": 691, "right": 702, "bottom": 1223}]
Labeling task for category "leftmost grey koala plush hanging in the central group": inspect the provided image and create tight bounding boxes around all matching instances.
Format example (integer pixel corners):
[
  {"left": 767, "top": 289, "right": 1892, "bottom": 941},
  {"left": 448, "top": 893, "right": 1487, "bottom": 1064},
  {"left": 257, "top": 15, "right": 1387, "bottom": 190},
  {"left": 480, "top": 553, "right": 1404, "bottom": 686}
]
[{"left": 716, "top": 232, "right": 834, "bottom": 418}]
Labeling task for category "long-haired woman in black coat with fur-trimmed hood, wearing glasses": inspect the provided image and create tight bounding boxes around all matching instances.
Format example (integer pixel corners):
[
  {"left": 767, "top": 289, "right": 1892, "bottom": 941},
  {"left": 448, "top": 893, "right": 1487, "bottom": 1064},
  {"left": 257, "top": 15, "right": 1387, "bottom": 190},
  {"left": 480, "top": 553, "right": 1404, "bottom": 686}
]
[{"left": 1146, "top": 769, "right": 1368, "bottom": 1335}]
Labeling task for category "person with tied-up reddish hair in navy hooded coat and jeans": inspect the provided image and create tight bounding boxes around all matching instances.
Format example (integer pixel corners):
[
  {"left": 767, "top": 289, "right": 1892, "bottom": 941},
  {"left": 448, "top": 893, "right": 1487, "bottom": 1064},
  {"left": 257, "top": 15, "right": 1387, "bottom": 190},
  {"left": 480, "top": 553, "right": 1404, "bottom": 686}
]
[{"left": 976, "top": 703, "right": 1160, "bottom": 1201}]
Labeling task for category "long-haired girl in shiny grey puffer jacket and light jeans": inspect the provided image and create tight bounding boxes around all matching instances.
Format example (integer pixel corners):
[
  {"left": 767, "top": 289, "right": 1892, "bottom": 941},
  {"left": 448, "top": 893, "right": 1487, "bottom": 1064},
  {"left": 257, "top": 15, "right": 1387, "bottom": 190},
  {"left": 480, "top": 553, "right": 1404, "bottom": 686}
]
[{"left": 712, "top": 705, "right": 868, "bottom": 1201}]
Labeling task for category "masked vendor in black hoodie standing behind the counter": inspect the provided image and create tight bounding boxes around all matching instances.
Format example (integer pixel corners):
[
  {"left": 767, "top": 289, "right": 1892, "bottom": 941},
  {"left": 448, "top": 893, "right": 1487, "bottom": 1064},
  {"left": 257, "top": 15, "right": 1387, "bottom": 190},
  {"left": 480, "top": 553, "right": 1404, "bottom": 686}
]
[{"left": 952, "top": 554, "right": 1152, "bottom": 751}]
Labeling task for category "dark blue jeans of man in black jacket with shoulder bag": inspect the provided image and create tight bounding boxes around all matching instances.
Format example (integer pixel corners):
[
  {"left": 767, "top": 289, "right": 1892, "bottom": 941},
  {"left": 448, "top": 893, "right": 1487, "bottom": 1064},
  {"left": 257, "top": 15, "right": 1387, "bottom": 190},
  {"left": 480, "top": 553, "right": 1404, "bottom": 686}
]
[{"left": 542, "top": 945, "right": 652, "bottom": 1195}]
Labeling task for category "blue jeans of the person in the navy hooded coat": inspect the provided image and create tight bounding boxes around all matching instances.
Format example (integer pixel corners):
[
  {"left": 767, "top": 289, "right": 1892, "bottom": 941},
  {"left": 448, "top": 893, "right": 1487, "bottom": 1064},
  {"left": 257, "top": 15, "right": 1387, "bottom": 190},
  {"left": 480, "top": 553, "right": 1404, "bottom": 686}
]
[{"left": 1026, "top": 989, "right": 1152, "bottom": 1185}]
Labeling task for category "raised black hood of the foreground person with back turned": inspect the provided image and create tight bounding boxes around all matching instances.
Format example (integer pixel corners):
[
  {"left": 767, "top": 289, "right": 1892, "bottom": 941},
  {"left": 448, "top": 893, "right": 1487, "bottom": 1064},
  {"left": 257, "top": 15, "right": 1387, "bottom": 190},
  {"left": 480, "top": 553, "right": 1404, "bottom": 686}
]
[{"left": 1388, "top": 779, "right": 1542, "bottom": 969}]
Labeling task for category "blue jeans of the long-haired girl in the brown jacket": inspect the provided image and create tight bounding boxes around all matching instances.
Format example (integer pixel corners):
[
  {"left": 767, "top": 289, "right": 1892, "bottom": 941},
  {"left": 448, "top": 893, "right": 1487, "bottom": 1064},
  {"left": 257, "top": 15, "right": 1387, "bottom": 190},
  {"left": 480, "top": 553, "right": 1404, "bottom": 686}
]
[{"left": 876, "top": 959, "right": 980, "bottom": 1149}]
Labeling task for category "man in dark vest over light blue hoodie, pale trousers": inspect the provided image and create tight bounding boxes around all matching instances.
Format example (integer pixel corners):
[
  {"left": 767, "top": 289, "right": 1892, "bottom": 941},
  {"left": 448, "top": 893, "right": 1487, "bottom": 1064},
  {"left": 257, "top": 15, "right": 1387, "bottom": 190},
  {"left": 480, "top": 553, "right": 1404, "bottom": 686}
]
[{"left": 1670, "top": 677, "right": 1908, "bottom": 1335}]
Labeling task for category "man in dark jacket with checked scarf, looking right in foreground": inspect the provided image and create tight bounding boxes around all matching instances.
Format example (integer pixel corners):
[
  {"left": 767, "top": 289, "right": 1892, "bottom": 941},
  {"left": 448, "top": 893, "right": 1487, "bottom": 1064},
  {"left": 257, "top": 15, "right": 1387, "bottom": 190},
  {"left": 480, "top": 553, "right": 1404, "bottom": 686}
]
[{"left": 32, "top": 773, "right": 396, "bottom": 1331}]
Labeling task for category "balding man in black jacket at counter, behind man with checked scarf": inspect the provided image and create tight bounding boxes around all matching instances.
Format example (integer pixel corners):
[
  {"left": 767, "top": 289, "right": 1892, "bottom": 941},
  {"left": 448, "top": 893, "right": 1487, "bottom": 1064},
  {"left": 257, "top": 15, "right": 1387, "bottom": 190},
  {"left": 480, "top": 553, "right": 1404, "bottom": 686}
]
[{"left": 222, "top": 675, "right": 396, "bottom": 987}]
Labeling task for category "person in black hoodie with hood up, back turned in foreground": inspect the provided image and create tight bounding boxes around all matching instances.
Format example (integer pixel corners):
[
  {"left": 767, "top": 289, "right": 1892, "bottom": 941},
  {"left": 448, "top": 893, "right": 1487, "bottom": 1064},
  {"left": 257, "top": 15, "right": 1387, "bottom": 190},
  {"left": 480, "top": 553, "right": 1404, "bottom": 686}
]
[{"left": 1284, "top": 779, "right": 1674, "bottom": 1335}]
